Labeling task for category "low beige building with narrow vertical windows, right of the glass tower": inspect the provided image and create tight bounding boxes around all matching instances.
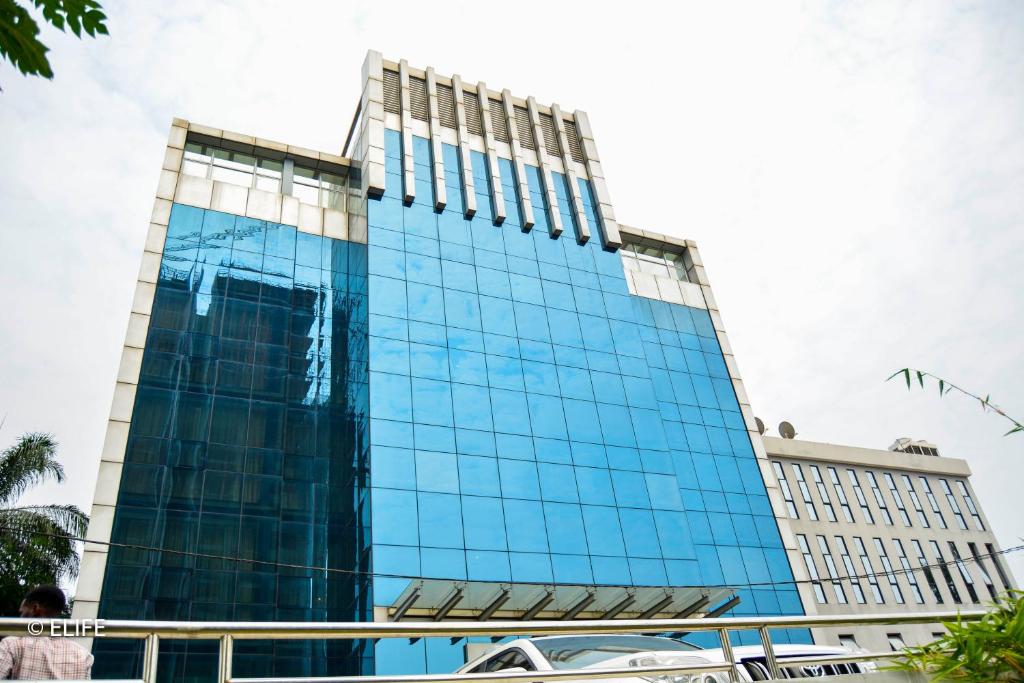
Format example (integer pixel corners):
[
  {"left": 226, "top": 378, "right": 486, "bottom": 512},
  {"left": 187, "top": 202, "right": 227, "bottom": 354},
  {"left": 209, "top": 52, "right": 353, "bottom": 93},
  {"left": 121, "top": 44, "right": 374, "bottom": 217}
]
[{"left": 763, "top": 436, "right": 1014, "bottom": 651}]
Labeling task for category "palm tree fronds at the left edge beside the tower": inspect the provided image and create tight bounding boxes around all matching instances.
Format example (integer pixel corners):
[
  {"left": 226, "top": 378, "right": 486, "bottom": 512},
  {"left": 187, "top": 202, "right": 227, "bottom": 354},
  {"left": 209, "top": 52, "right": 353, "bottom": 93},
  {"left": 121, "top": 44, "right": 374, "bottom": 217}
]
[{"left": 0, "top": 434, "right": 89, "bottom": 616}]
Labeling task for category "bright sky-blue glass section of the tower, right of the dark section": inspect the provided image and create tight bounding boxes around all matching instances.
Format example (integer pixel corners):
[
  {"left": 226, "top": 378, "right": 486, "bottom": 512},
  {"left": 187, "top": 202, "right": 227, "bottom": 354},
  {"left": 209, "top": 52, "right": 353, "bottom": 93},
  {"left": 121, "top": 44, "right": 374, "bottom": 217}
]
[{"left": 368, "top": 130, "right": 806, "bottom": 673}]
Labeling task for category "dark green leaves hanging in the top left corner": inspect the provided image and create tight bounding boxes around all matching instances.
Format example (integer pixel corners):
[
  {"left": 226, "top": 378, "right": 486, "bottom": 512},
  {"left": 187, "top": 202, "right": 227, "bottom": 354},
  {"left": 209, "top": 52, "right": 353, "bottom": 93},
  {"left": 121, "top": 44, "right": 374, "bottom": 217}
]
[{"left": 0, "top": 0, "right": 108, "bottom": 84}]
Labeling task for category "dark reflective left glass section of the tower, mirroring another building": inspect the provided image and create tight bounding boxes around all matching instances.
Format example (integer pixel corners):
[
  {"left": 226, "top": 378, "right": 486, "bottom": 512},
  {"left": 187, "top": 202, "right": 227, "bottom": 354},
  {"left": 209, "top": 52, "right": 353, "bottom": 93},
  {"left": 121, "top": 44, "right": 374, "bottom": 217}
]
[{"left": 94, "top": 205, "right": 371, "bottom": 681}]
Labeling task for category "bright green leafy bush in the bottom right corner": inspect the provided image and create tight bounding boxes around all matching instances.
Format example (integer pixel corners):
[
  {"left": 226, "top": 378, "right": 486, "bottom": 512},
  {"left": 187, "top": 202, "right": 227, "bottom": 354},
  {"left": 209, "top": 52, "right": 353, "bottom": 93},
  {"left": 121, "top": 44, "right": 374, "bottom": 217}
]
[{"left": 891, "top": 591, "right": 1024, "bottom": 683}]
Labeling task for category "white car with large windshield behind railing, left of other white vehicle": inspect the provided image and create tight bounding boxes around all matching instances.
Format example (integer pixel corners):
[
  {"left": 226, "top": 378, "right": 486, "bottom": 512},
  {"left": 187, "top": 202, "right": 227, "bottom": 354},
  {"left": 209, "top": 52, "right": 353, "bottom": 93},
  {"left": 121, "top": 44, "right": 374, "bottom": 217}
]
[{"left": 456, "top": 635, "right": 728, "bottom": 683}]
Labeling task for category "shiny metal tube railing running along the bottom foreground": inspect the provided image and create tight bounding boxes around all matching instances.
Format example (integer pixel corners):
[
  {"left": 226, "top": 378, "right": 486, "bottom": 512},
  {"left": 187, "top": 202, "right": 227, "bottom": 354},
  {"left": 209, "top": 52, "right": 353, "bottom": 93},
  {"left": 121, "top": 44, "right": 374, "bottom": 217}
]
[{"left": 0, "top": 611, "right": 985, "bottom": 683}]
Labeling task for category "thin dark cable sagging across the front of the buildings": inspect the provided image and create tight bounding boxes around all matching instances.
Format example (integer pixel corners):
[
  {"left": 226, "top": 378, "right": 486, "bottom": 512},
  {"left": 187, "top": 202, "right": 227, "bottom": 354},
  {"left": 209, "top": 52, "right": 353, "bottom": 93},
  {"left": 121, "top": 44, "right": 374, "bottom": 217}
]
[{"left": 0, "top": 525, "right": 1024, "bottom": 589}]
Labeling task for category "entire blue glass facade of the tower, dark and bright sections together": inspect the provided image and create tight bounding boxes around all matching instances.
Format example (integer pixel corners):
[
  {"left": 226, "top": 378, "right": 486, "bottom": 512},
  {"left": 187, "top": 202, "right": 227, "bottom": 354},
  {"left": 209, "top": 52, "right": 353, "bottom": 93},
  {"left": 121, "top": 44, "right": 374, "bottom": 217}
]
[{"left": 95, "top": 122, "right": 808, "bottom": 681}]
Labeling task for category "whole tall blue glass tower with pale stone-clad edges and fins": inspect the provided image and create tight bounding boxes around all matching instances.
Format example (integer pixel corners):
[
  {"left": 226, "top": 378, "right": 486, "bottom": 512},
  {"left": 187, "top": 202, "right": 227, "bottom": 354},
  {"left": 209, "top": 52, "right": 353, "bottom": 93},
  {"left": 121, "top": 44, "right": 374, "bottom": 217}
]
[{"left": 75, "top": 52, "right": 809, "bottom": 680}]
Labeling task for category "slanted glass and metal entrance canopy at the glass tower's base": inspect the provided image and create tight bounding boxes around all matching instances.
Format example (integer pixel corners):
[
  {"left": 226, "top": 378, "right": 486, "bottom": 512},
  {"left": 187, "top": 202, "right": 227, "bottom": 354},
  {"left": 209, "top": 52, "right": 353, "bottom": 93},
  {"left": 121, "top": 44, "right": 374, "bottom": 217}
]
[{"left": 387, "top": 579, "right": 738, "bottom": 622}]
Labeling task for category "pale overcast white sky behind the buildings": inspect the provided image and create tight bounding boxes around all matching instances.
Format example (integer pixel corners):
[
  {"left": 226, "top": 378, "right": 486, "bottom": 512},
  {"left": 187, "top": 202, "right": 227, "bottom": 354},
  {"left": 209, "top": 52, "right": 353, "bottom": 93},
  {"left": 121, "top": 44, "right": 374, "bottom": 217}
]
[{"left": 0, "top": 0, "right": 1024, "bottom": 581}]
